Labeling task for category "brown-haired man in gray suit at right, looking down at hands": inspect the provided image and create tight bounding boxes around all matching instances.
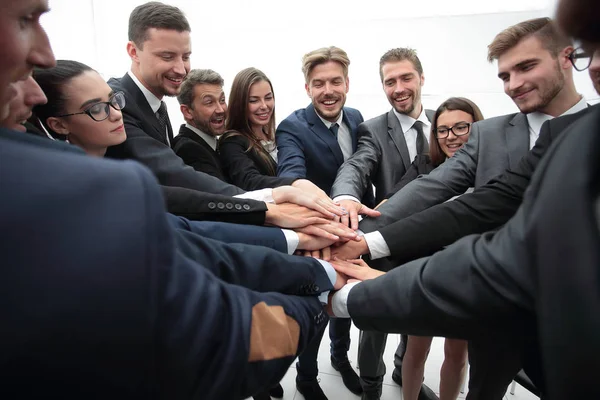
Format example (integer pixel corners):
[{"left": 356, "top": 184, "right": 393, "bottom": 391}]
[{"left": 346, "top": 18, "right": 586, "bottom": 399}]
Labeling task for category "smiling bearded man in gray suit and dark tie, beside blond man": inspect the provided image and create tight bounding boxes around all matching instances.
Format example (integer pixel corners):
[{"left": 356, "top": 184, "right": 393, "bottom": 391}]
[{"left": 331, "top": 48, "right": 437, "bottom": 399}]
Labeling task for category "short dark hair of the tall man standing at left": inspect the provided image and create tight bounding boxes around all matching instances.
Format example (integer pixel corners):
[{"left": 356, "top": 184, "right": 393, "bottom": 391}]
[{"left": 128, "top": 1, "right": 192, "bottom": 49}]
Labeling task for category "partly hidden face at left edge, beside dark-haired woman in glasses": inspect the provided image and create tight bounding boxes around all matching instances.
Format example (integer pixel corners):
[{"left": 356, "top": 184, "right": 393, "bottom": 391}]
[{"left": 0, "top": 76, "right": 48, "bottom": 132}]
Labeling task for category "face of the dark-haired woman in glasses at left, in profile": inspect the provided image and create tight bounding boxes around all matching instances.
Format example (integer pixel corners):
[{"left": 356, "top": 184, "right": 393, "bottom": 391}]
[{"left": 60, "top": 71, "right": 126, "bottom": 156}]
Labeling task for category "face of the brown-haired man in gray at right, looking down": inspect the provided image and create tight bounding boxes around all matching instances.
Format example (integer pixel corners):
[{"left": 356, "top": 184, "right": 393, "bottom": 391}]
[{"left": 498, "top": 36, "right": 570, "bottom": 114}]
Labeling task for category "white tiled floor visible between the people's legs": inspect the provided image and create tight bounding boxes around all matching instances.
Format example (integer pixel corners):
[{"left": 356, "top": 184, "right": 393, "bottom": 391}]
[{"left": 248, "top": 325, "right": 538, "bottom": 400}]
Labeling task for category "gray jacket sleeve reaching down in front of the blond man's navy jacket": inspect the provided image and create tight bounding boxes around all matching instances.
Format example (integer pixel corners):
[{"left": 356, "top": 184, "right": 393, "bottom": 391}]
[{"left": 331, "top": 123, "right": 381, "bottom": 199}]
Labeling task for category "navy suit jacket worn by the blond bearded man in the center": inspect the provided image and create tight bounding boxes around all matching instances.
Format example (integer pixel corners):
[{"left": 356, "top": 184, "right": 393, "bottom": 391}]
[{"left": 275, "top": 104, "right": 373, "bottom": 204}]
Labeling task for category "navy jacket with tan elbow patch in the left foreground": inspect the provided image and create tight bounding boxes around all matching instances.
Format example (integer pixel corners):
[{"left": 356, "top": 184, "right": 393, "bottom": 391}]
[{"left": 0, "top": 129, "right": 331, "bottom": 399}]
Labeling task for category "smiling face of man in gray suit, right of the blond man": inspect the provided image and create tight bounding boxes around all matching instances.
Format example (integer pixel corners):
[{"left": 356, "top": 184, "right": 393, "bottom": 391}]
[{"left": 381, "top": 60, "right": 425, "bottom": 119}]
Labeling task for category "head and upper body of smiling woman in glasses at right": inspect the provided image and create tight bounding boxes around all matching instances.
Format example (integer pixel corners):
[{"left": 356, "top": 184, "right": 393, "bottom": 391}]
[{"left": 385, "top": 97, "right": 483, "bottom": 199}]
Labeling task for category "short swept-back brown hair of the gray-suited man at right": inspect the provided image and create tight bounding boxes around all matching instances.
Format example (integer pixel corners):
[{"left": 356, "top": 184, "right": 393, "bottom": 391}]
[{"left": 488, "top": 17, "right": 573, "bottom": 62}]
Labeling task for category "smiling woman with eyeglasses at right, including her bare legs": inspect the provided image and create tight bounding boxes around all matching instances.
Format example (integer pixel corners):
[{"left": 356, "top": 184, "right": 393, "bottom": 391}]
[{"left": 386, "top": 97, "right": 483, "bottom": 400}]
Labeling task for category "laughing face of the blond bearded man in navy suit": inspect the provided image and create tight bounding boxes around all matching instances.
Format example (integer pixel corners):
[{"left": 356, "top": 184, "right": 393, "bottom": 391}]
[{"left": 304, "top": 61, "right": 349, "bottom": 122}]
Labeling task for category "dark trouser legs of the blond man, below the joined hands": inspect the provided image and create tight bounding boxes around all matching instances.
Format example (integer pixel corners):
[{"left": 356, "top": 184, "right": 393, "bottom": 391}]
[{"left": 296, "top": 318, "right": 352, "bottom": 381}]
